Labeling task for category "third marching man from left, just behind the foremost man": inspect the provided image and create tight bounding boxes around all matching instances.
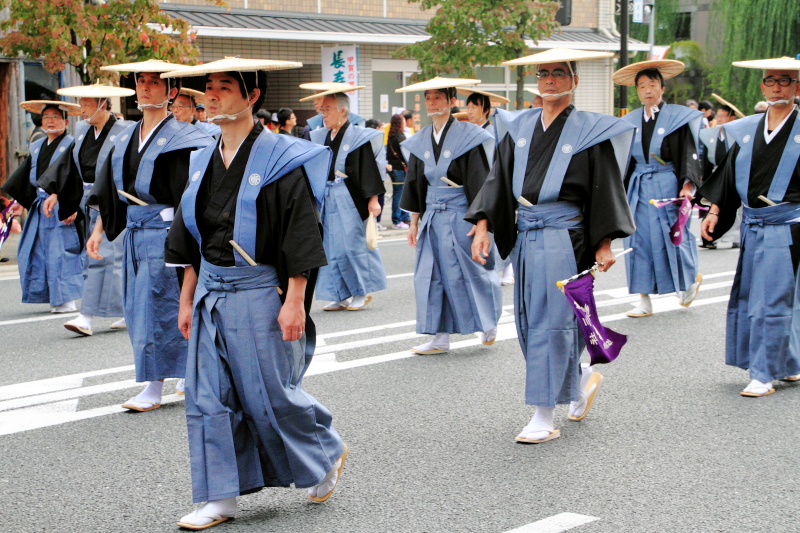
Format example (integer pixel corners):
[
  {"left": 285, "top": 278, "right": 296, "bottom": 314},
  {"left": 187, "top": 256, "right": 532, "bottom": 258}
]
[{"left": 86, "top": 60, "right": 213, "bottom": 411}]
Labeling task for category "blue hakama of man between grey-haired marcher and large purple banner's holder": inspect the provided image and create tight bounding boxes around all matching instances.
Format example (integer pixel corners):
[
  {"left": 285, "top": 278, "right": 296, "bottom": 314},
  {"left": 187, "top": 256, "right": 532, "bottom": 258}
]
[{"left": 414, "top": 187, "right": 503, "bottom": 335}]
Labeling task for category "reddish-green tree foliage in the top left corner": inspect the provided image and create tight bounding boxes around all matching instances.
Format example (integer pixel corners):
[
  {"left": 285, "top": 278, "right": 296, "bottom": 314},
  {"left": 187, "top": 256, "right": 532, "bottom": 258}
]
[{"left": 0, "top": 0, "right": 223, "bottom": 84}]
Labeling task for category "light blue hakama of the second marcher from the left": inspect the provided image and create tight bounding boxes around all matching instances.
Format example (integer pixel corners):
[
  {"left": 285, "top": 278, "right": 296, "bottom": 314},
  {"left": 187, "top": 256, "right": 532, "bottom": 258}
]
[{"left": 81, "top": 188, "right": 126, "bottom": 317}]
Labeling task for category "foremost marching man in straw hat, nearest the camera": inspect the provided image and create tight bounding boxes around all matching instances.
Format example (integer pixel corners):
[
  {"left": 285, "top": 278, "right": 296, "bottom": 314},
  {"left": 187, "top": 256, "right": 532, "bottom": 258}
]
[{"left": 164, "top": 58, "right": 347, "bottom": 529}]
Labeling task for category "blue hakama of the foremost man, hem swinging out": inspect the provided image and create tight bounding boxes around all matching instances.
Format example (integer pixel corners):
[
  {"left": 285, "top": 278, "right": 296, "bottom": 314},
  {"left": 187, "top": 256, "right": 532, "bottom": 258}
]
[{"left": 186, "top": 261, "right": 344, "bottom": 502}]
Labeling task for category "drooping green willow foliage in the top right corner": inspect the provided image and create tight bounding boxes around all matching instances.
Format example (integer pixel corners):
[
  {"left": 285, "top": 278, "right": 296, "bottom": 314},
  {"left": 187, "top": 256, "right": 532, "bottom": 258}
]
[{"left": 714, "top": 0, "right": 800, "bottom": 110}]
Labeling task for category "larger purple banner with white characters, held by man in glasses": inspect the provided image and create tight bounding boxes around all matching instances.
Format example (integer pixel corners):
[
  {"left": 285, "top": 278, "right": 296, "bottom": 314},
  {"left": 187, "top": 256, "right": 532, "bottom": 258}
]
[{"left": 564, "top": 273, "right": 628, "bottom": 365}]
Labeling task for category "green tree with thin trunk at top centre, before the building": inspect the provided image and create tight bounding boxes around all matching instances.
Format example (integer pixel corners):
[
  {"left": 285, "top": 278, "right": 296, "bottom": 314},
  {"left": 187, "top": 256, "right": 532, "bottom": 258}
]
[{"left": 395, "top": 0, "right": 559, "bottom": 109}]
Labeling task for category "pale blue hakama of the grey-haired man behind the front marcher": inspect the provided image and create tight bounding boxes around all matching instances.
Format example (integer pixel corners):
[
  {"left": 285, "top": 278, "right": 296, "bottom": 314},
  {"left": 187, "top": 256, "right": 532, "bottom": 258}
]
[{"left": 316, "top": 181, "right": 386, "bottom": 302}]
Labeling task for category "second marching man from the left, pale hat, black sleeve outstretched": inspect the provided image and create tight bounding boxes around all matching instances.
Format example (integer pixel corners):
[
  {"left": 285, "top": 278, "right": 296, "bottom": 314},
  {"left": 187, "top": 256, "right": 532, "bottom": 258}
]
[{"left": 34, "top": 83, "right": 134, "bottom": 336}]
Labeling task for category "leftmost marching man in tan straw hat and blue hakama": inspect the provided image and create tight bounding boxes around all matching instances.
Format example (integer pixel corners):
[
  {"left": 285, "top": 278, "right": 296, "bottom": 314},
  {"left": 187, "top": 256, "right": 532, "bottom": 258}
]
[{"left": 2, "top": 100, "right": 83, "bottom": 313}]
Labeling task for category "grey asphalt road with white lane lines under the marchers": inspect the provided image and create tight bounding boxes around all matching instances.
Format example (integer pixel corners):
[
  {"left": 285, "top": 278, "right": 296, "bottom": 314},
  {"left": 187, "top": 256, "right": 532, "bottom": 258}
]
[{"left": 0, "top": 234, "right": 800, "bottom": 533}]
